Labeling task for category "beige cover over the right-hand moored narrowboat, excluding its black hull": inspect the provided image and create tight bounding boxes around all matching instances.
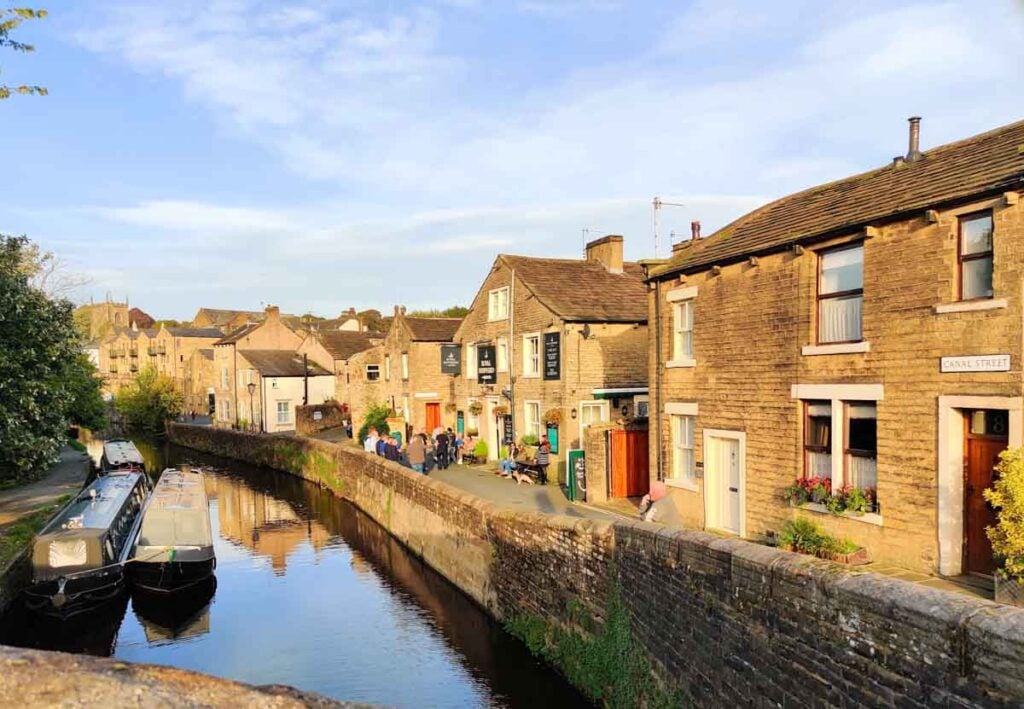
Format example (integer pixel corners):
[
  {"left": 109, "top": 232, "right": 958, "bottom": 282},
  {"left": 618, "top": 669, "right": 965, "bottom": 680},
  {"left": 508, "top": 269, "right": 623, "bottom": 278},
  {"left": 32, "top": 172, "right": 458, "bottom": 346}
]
[{"left": 138, "top": 468, "right": 213, "bottom": 547}]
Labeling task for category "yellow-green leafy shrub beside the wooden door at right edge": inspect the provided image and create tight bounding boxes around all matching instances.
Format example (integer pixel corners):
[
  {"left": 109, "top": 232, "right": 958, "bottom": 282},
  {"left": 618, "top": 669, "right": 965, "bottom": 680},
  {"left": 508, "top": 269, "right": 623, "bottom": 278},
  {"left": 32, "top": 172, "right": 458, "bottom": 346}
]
[{"left": 984, "top": 448, "right": 1024, "bottom": 579}]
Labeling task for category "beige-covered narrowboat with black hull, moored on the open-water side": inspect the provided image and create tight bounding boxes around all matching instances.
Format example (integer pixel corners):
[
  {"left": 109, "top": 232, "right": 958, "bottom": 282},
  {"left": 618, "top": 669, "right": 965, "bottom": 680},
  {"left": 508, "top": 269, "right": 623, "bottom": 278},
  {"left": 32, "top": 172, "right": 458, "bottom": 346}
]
[{"left": 128, "top": 468, "right": 217, "bottom": 593}]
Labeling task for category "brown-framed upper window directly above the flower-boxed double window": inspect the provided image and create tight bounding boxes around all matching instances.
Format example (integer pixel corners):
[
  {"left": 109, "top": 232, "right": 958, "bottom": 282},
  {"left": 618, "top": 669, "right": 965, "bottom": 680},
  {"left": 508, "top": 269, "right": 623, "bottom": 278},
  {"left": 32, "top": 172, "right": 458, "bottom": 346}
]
[{"left": 818, "top": 244, "right": 864, "bottom": 344}]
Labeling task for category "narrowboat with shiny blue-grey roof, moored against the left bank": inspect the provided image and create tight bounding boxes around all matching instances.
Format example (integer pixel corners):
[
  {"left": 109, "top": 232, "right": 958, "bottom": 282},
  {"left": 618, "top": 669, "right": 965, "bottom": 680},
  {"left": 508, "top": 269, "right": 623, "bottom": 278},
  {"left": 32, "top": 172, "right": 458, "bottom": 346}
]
[{"left": 25, "top": 471, "right": 150, "bottom": 618}]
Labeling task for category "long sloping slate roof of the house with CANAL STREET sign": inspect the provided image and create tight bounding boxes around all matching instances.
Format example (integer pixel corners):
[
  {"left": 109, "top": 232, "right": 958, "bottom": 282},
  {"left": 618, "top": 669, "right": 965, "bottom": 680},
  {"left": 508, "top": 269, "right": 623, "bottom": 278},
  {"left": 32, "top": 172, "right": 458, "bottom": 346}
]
[{"left": 651, "top": 121, "right": 1024, "bottom": 278}]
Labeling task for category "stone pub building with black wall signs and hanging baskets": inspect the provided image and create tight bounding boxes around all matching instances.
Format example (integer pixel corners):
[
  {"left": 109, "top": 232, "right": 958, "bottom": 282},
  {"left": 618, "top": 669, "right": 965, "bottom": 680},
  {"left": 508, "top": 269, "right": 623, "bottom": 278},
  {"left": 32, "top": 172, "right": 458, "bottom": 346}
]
[{"left": 452, "top": 235, "right": 647, "bottom": 482}]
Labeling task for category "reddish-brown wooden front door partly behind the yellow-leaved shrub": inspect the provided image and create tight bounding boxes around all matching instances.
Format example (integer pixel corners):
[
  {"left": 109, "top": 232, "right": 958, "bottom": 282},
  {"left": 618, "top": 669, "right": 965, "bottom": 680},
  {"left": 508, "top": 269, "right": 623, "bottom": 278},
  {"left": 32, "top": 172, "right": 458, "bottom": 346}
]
[{"left": 964, "top": 437, "right": 1007, "bottom": 574}]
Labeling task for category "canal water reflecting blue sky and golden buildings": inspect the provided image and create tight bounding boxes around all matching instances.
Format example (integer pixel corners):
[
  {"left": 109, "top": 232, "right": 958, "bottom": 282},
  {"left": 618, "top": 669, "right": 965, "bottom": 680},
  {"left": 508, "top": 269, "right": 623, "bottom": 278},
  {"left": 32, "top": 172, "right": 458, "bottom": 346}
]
[{"left": 0, "top": 442, "right": 586, "bottom": 707}]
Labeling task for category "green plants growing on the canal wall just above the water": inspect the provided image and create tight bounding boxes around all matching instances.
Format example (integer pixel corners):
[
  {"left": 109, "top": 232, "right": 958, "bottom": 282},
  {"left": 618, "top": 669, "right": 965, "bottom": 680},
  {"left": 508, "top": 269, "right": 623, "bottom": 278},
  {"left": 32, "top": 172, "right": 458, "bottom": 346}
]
[{"left": 506, "top": 590, "right": 682, "bottom": 707}]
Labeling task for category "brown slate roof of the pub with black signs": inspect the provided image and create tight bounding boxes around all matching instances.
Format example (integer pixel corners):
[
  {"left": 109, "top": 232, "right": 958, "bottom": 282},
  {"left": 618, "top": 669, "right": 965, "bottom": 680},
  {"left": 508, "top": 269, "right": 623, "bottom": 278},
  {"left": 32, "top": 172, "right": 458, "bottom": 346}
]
[{"left": 499, "top": 254, "right": 647, "bottom": 323}]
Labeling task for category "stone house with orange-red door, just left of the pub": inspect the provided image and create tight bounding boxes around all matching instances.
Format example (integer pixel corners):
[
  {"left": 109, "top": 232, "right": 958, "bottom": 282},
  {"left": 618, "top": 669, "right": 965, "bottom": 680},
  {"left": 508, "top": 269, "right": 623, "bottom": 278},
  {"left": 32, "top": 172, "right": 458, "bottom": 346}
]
[{"left": 348, "top": 305, "right": 462, "bottom": 438}]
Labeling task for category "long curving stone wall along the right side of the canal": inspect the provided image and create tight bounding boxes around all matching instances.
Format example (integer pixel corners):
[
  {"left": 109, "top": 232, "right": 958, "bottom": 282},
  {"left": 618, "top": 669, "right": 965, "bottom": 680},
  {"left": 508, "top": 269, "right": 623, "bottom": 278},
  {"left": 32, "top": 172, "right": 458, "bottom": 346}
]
[{"left": 169, "top": 424, "right": 1024, "bottom": 707}]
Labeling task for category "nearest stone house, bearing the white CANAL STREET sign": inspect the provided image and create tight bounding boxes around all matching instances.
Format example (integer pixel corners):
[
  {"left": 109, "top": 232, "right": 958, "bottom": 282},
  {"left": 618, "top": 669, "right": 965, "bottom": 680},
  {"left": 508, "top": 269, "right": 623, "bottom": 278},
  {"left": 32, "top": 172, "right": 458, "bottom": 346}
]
[{"left": 648, "top": 119, "right": 1024, "bottom": 576}]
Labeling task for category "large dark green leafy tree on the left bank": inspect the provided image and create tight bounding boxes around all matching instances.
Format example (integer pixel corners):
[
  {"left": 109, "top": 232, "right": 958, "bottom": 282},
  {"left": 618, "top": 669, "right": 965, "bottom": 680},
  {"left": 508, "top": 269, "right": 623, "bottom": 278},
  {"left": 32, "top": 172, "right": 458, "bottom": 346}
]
[{"left": 0, "top": 235, "right": 88, "bottom": 482}]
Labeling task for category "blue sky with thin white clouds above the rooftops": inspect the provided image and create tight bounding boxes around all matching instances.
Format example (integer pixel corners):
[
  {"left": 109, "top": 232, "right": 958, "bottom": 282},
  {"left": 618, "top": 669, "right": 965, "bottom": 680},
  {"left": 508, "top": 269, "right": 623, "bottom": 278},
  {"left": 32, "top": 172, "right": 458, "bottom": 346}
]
[{"left": 0, "top": 0, "right": 1024, "bottom": 318}]
